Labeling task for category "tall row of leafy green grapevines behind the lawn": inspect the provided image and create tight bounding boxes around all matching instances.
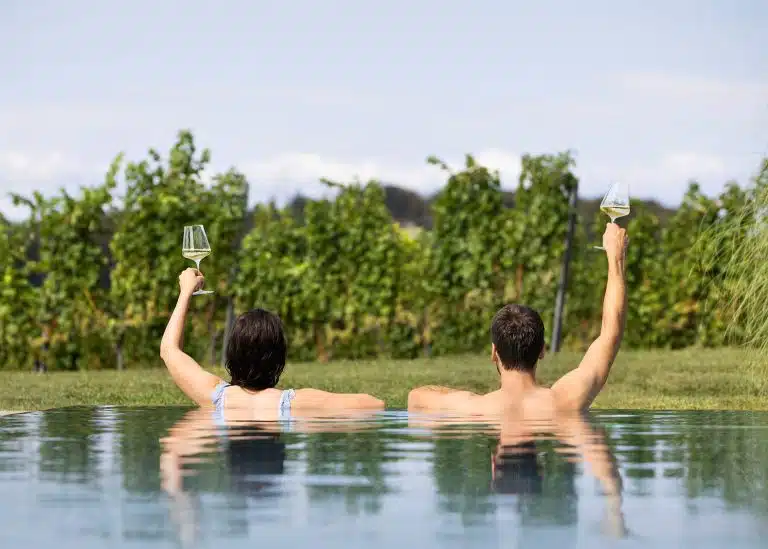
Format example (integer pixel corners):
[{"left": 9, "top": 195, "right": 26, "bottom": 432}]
[{"left": 0, "top": 131, "right": 768, "bottom": 369}]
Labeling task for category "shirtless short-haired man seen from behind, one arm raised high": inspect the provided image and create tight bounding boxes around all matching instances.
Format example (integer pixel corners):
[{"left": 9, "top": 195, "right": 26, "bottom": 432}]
[{"left": 408, "top": 223, "right": 629, "bottom": 419}]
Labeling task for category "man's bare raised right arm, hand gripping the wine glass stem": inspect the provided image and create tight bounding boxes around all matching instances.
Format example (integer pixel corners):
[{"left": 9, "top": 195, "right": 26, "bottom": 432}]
[{"left": 552, "top": 223, "right": 629, "bottom": 410}]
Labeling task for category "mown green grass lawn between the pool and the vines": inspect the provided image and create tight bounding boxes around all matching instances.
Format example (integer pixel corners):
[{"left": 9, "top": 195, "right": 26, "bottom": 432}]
[{"left": 0, "top": 349, "right": 768, "bottom": 410}]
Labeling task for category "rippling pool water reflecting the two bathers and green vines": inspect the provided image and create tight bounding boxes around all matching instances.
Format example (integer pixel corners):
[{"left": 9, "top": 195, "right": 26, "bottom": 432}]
[{"left": 0, "top": 407, "right": 768, "bottom": 549}]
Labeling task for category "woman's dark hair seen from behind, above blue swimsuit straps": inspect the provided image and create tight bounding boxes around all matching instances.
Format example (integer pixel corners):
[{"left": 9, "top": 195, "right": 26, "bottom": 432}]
[{"left": 226, "top": 309, "right": 288, "bottom": 391}]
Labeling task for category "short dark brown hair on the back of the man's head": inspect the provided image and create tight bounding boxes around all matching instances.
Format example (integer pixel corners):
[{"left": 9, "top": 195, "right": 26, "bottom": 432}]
[{"left": 491, "top": 305, "right": 544, "bottom": 371}]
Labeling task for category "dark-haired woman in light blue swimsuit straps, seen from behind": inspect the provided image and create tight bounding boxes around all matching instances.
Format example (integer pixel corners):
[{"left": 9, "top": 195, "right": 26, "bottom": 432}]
[{"left": 160, "top": 268, "right": 384, "bottom": 416}]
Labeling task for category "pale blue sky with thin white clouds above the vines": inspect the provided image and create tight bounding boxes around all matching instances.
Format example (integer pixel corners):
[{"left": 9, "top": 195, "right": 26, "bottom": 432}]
[{"left": 0, "top": 0, "right": 768, "bottom": 217}]
